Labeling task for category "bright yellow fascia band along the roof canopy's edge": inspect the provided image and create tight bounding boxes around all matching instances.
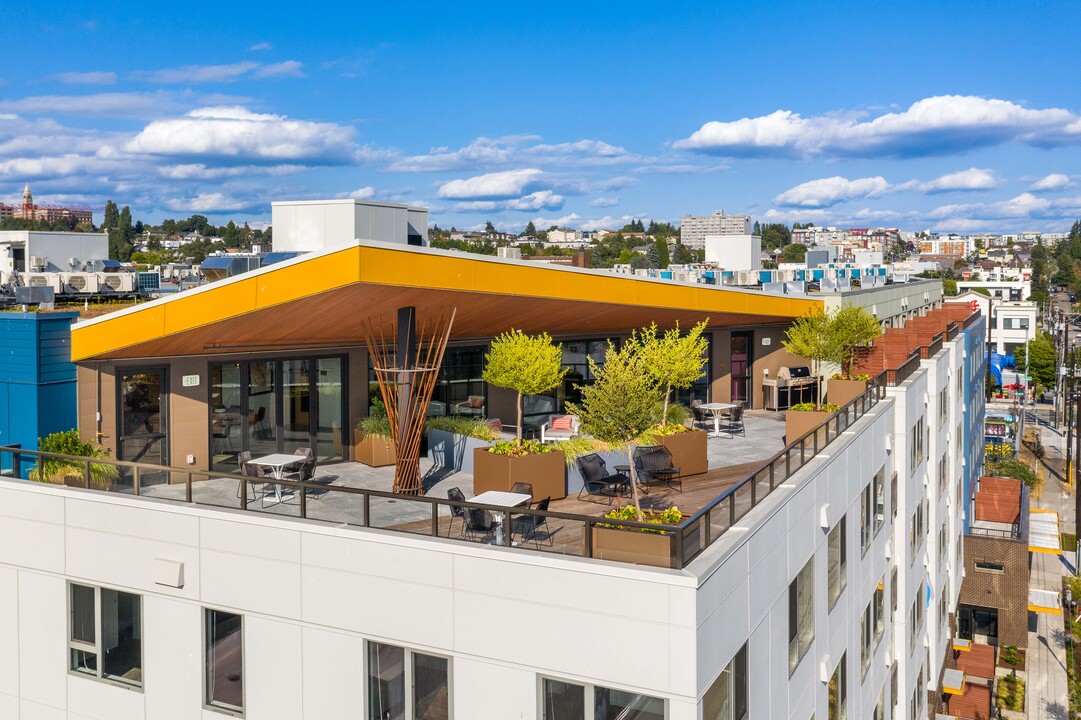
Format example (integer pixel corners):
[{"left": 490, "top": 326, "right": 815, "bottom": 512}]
[{"left": 71, "top": 243, "right": 823, "bottom": 361}]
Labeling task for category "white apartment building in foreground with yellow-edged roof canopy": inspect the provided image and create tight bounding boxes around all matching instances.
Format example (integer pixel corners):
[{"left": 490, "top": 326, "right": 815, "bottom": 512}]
[{"left": 0, "top": 234, "right": 985, "bottom": 720}]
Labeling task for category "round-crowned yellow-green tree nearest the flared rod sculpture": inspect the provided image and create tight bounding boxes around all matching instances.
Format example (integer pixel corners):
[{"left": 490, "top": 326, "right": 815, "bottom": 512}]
[{"left": 483, "top": 330, "right": 568, "bottom": 442}]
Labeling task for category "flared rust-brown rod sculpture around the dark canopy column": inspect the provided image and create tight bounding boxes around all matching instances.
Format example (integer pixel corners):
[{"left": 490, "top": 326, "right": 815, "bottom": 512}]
[{"left": 363, "top": 307, "right": 456, "bottom": 495}]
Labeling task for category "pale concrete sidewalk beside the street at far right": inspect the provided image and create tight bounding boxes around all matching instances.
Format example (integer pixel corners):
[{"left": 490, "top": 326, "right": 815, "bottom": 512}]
[{"left": 1025, "top": 427, "right": 1073, "bottom": 720}]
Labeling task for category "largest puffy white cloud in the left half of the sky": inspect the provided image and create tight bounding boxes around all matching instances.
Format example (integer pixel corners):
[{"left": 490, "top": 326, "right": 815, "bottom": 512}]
[{"left": 125, "top": 107, "right": 356, "bottom": 164}]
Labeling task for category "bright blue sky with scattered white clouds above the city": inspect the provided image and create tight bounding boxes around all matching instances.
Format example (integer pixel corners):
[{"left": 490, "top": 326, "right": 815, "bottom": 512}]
[{"left": 0, "top": 0, "right": 1081, "bottom": 232}]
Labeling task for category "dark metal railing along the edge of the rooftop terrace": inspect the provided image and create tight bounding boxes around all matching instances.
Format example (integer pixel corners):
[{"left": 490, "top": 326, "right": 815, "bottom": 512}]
[{"left": 0, "top": 371, "right": 890, "bottom": 569}]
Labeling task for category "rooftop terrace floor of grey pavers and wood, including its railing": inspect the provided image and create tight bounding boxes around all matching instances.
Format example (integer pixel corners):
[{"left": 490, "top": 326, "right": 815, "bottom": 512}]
[{"left": 0, "top": 385, "right": 884, "bottom": 569}]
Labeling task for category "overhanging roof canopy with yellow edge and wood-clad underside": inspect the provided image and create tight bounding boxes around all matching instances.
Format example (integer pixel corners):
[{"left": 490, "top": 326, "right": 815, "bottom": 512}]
[{"left": 71, "top": 241, "right": 823, "bottom": 361}]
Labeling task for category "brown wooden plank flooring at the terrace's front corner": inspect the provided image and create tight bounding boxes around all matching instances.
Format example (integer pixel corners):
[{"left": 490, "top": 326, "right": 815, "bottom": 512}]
[{"left": 385, "top": 461, "right": 778, "bottom": 556}]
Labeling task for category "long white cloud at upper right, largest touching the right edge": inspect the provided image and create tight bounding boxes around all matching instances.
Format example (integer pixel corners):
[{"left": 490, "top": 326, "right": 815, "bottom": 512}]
[{"left": 672, "top": 95, "right": 1081, "bottom": 158}]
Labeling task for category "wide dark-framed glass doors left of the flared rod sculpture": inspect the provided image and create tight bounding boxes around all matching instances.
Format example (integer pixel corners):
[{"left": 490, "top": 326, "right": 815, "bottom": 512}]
[{"left": 210, "top": 357, "right": 347, "bottom": 471}]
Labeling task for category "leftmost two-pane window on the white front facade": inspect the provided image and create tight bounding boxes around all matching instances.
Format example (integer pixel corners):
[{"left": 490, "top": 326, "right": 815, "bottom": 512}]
[{"left": 68, "top": 583, "right": 143, "bottom": 686}]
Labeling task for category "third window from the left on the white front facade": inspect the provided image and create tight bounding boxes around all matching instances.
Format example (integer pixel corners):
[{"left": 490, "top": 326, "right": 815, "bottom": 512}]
[{"left": 368, "top": 642, "right": 445, "bottom": 720}]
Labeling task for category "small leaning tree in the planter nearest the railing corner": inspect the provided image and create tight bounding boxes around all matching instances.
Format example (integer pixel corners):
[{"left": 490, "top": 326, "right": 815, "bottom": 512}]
[{"left": 570, "top": 336, "right": 665, "bottom": 522}]
